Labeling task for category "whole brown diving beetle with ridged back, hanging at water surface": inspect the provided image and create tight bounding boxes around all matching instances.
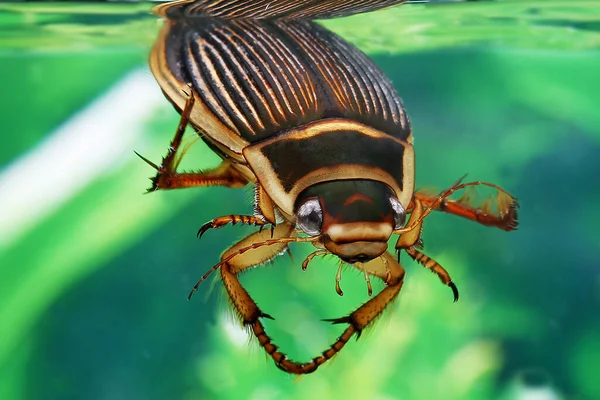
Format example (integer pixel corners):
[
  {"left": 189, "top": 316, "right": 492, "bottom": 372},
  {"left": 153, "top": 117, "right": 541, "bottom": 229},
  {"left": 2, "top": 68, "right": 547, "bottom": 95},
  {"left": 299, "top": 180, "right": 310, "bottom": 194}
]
[{"left": 140, "top": 0, "right": 518, "bottom": 374}]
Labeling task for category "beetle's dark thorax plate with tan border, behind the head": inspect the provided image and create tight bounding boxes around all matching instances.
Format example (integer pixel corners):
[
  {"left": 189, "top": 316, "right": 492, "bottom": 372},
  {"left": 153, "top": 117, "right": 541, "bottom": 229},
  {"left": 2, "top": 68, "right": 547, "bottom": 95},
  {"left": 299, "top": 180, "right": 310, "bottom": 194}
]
[{"left": 243, "top": 118, "right": 414, "bottom": 222}]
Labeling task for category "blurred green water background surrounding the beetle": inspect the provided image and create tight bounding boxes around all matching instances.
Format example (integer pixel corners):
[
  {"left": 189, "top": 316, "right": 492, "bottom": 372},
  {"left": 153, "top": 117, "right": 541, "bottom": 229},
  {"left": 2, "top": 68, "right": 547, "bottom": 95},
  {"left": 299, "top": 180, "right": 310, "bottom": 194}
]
[{"left": 0, "top": 1, "right": 600, "bottom": 400}]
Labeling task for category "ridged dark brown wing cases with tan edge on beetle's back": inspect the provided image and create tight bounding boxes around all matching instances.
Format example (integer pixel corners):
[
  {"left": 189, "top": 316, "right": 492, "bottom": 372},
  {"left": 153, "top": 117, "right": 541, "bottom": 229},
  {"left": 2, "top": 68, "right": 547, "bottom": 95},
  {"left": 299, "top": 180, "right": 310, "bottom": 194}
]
[{"left": 151, "top": 18, "right": 410, "bottom": 143}]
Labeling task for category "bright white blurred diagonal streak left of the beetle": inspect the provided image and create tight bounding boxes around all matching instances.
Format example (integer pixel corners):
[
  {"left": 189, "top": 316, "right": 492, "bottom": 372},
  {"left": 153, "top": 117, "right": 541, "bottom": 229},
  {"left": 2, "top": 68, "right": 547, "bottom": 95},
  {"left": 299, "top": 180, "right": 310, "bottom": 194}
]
[{"left": 0, "top": 69, "right": 166, "bottom": 247}]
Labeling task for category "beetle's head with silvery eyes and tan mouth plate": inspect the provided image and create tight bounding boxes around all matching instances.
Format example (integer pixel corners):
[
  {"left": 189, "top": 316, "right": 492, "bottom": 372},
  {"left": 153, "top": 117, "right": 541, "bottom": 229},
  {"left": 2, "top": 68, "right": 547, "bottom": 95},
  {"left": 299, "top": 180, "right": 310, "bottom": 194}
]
[{"left": 295, "top": 180, "right": 406, "bottom": 263}]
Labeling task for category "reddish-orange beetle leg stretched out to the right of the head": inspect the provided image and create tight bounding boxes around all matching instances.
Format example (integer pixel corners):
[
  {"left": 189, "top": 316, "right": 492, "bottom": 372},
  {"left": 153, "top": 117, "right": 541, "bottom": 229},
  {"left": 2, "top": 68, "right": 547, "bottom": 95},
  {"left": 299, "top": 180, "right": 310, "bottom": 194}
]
[{"left": 415, "top": 181, "right": 519, "bottom": 231}]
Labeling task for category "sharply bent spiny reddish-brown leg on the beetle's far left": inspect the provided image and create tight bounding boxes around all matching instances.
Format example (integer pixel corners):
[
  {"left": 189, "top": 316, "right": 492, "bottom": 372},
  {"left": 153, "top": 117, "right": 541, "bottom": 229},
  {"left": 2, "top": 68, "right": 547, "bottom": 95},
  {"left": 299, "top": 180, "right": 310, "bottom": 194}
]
[{"left": 135, "top": 89, "right": 248, "bottom": 192}]
